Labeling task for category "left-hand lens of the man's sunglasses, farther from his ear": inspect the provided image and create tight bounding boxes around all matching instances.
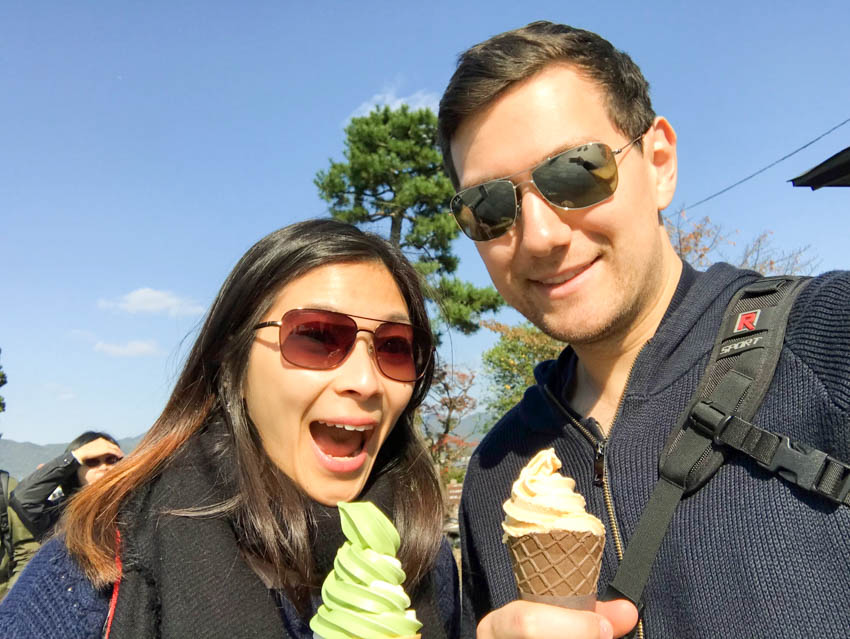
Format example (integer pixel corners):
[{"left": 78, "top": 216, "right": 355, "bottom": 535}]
[{"left": 451, "top": 180, "right": 516, "bottom": 242}]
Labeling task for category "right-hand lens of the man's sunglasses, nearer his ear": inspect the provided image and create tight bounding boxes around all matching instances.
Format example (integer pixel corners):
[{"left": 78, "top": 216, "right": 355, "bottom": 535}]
[{"left": 531, "top": 142, "right": 617, "bottom": 209}]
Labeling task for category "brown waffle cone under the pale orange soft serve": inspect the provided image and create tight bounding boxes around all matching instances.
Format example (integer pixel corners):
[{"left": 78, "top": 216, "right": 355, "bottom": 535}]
[{"left": 505, "top": 530, "right": 605, "bottom": 607}]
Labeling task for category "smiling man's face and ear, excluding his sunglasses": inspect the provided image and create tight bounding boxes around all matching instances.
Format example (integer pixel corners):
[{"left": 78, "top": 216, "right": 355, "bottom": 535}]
[{"left": 451, "top": 64, "right": 678, "bottom": 344}]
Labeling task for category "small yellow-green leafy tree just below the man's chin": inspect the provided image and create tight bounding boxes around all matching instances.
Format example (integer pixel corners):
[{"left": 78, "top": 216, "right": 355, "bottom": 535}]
[{"left": 482, "top": 322, "right": 566, "bottom": 415}]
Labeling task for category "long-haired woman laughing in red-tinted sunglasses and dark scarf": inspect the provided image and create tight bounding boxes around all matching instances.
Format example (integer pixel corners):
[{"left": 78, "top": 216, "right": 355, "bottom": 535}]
[{"left": 0, "top": 220, "right": 460, "bottom": 639}]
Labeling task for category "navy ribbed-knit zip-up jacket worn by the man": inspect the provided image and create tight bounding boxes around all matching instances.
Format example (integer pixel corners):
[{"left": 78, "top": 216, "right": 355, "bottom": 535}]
[{"left": 460, "top": 264, "right": 850, "bottom": 639}]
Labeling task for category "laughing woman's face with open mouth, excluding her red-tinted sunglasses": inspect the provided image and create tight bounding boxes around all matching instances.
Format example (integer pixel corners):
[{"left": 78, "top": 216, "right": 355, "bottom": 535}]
[{"left": 243, "top": 262, "right": 414, "bottom": 505}]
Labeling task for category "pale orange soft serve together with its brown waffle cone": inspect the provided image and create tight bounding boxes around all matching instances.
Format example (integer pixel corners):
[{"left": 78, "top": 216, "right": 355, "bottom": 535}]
[{"left": 502, "top": 448, "right": 605, "bottom": 609}]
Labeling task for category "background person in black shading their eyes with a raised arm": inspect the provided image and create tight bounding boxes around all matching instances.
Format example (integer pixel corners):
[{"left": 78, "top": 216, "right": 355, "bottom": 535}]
[{"left": 9, "top": 430, "right": 124, "bottom": 540}]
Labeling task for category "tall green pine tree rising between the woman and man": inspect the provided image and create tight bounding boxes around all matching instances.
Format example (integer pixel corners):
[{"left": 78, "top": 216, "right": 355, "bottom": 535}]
[{"left": 314, "top": 105, "right": 503, "bottom": 333}]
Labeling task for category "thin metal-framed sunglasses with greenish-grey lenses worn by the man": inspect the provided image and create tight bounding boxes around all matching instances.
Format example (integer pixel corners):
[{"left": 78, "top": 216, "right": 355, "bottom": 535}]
[{"left": 450, "top": 132, "right": 646, "bottom": 242}]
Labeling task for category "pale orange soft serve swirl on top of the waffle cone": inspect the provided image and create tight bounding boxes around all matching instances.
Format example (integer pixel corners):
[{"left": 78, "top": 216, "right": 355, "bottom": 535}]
[{"left": 502, "top": 448, "right": 605, "bottom": 539}]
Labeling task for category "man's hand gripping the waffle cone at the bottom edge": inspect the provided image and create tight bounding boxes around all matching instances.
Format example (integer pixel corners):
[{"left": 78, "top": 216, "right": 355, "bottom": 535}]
[{"left": 477, "top": 599, "right": 638, "bottom": 639}]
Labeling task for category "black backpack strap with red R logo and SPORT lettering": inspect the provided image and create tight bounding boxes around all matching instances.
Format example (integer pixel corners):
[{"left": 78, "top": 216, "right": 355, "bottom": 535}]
[{"left": 603, "top": 276, "right": 850, "bottom": 612}]
